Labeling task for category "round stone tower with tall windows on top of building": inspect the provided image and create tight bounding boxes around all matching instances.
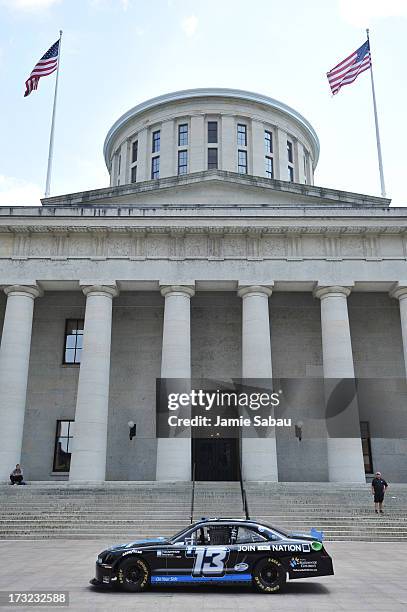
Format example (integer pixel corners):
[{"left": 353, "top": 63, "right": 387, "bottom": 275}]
[{"left": 104, "top": 88, "right": 319, "bottom": 186}]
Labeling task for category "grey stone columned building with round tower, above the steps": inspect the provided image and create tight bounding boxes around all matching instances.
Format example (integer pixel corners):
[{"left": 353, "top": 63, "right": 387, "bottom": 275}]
[{"left": 0, "top": 89, "right": 407, "bottom": 482}]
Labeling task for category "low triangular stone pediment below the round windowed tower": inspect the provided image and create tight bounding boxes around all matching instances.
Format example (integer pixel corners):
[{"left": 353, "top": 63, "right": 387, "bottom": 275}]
[{"left": 42, "top": 170, "right": 390, "bottom": 208}]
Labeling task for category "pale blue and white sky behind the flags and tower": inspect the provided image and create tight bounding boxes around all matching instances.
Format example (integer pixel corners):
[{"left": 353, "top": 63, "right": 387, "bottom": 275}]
[{"left": 0, "top": 0, "right": 407, "bottom": 206}]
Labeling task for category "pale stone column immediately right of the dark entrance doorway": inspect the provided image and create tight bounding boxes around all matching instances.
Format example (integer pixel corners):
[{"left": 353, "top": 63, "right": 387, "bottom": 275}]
[{"left": 238, "top": 285, "right": 278, "bottom": 481}]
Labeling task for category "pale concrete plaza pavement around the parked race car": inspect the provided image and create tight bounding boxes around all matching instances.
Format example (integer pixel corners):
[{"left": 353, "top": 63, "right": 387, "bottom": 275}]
[{"left": 0, "top": 540, "right": 407, "bottom": 612}]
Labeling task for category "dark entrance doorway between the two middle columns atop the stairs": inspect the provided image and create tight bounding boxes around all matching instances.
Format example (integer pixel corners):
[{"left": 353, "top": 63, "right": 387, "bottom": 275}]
[{"left": 192, "top": 437, "right": 240, "bottom": 481}]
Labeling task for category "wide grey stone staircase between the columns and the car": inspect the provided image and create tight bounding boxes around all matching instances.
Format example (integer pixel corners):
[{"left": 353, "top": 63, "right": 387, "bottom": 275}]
[{"left": 0, "top": 482, "right": 407, "bottom": 542}]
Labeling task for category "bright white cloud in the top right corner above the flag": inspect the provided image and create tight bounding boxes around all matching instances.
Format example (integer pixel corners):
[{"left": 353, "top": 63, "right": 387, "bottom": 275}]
[{"left": 339, "top": 0, "right": 407, "bottom": 27}]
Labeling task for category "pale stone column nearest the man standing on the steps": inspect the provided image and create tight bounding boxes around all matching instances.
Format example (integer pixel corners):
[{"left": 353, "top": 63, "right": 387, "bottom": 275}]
[{"left": 314, "top": 286, "right": 366, "bottom": 482}]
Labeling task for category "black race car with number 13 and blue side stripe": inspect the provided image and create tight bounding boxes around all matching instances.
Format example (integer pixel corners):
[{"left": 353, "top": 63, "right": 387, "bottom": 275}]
[{"left": 90, "top": 518, "right": 334, "bottom": 593}]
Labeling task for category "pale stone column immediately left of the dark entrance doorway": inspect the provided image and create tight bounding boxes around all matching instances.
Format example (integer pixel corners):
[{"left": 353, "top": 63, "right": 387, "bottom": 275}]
[{"left": 156, "top": 285, "right": 195, "bottom": 480}]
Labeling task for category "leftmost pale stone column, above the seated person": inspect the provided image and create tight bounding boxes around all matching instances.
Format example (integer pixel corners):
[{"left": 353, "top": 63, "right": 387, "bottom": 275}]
[{"left": 0, "top": 285, "right": 41, "bottom": 481}]
